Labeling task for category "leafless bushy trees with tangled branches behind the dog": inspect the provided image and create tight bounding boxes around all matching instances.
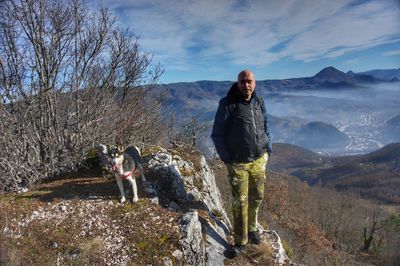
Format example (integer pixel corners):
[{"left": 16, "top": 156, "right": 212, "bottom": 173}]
[{"left": 0, "top": 0, "right": 162, "bottom": 190}]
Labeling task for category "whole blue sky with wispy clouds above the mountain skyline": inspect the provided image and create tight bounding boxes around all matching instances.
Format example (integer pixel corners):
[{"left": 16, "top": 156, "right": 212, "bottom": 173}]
[{"left": 92, "top": 0, "right": 400, "bottom": 83}]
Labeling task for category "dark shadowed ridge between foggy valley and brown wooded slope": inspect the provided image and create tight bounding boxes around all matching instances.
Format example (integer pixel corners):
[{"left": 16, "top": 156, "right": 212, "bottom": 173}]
[{"left": 270, "top": 143, "right": 400, "bottom": 204}]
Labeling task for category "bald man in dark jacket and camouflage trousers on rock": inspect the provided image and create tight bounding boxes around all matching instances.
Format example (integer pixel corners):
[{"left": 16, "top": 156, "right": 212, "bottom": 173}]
[{"left": 211, "top": 70, "right": 272, "bottom": 257}]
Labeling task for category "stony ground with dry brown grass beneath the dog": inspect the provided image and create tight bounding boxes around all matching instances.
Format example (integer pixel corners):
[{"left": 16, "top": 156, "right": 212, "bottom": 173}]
[{"left": 0, "top": 174, "right": 183, "bottom": 265}]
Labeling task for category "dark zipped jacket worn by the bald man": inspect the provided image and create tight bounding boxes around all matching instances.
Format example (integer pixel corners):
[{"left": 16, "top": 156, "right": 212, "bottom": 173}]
[{"left": 211, "top": 83, "right": 272, "bottom": 163}]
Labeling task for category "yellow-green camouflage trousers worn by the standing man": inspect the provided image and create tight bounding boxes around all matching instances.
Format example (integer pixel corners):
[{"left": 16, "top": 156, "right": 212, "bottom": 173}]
[{"left": 227, "top": 153, "right": 268, "bottom": 245}]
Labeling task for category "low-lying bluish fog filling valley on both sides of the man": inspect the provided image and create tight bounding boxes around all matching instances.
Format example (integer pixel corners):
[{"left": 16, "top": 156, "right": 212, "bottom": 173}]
[{"left": 170, "top": 82, "right": 400, "bottom": 155}]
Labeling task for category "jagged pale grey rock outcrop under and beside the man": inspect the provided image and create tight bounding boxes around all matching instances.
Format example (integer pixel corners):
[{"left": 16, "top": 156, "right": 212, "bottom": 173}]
[{"left": 148, "top": 150, "right": 291, "bottom": 266}]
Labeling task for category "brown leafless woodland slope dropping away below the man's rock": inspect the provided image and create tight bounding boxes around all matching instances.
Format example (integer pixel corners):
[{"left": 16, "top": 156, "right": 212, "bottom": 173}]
[{"left": 213, "top": 158, "right": 400, "bottom": 265}]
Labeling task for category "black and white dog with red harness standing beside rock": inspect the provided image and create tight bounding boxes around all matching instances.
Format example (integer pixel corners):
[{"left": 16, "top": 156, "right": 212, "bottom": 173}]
[{"left": 99, "top": 144, "right": 146, "bottom": 203}]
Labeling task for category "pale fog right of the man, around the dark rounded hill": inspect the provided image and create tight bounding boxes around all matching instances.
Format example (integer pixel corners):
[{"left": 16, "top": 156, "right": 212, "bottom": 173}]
[{"left": 263, "top": 83, "right": 400, "bottom": 154}]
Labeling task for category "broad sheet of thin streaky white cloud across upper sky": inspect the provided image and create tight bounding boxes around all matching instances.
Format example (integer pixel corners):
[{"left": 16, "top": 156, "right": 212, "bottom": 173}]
[{"left": 95, "top": 0, "right": 400, "bottom": 70}]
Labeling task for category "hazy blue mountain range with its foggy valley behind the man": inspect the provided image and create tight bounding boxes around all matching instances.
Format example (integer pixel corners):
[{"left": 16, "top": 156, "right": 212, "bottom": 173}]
[{"left": 158, "top": 67, "right": 400, "bottom": 154}]
